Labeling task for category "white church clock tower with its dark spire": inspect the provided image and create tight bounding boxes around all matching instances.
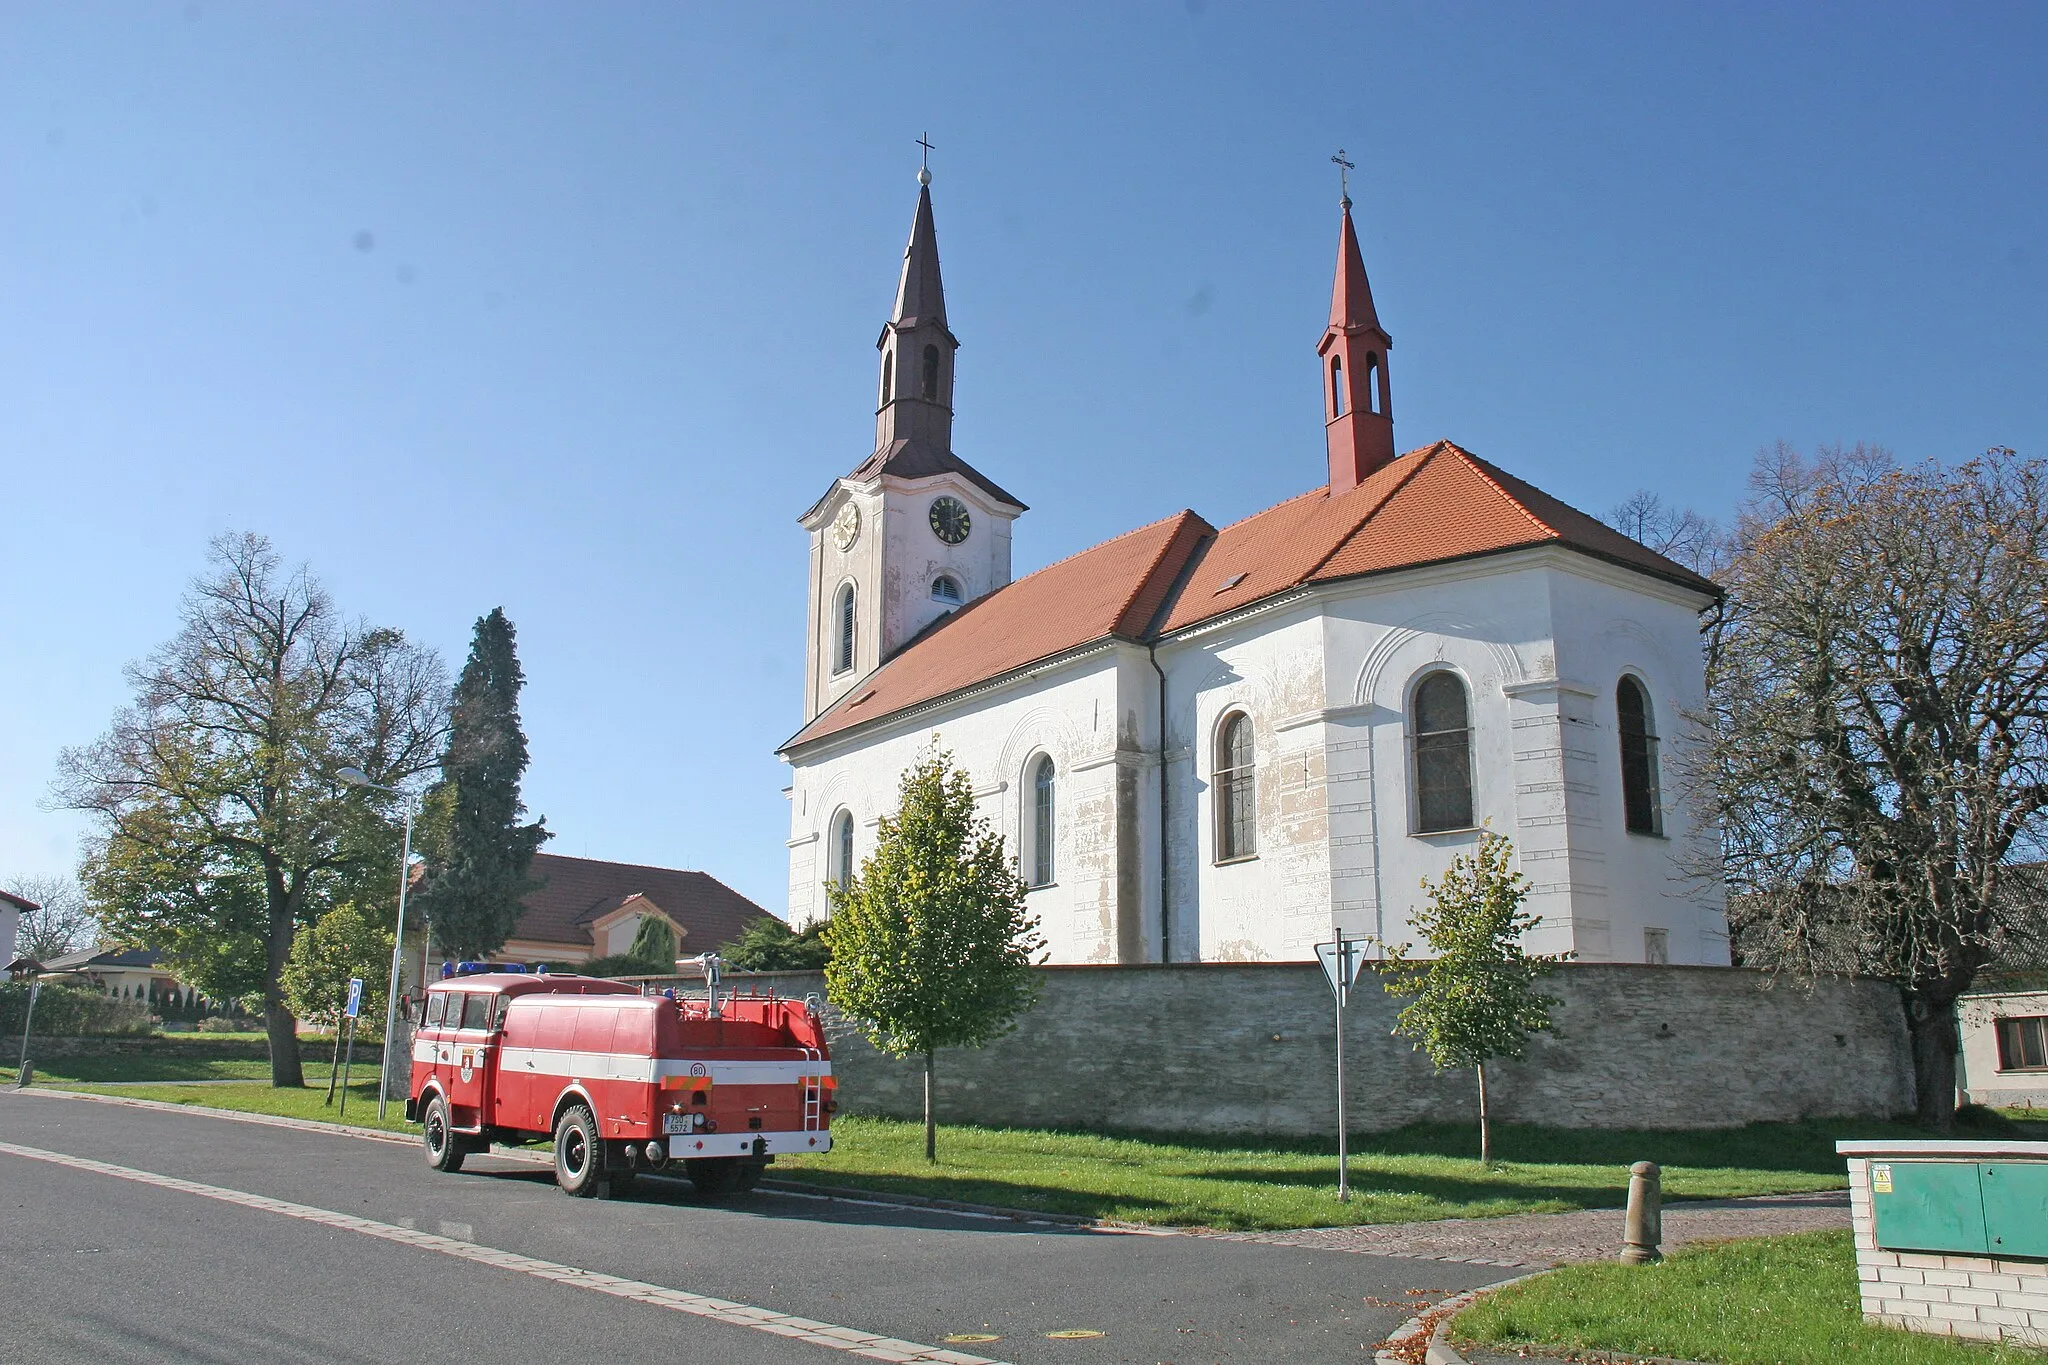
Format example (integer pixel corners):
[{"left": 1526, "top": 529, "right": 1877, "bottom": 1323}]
[{"left": 799, "top": 170, "right": 1024, "bottom": 722}]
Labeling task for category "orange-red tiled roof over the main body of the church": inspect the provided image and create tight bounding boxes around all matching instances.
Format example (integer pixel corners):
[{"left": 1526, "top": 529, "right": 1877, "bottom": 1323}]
[{"left": 782, "top": 440, "right": 1720, "bottom": 753}]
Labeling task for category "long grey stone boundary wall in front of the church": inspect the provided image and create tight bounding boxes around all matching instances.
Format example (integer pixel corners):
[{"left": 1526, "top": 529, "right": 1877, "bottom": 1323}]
[{"left": 729, "top": 962, "right": 1913, "bottom": 1136}]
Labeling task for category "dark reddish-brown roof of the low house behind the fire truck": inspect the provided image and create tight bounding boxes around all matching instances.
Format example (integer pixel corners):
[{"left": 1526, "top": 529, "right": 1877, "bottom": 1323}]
[{"left": 510, "top": 853, "right": 768, "bottom": 954}]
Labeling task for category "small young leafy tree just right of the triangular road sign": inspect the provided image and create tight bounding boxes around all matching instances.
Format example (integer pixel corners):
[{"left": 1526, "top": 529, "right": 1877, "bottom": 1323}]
[{"left": 1372, "top": 833, "right": 1565, "bottom": 1164}]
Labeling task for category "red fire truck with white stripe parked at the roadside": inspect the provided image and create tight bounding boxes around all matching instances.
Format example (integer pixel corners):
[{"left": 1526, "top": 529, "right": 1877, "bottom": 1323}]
[{"left": 406, "top": 962, "right": 836, "bottom": 1197}]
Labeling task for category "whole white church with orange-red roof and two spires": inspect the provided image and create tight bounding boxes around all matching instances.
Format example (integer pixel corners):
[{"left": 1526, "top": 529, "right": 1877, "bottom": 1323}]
[{"left": 780, "top": 176, "right": 1729, "bottom": 966}]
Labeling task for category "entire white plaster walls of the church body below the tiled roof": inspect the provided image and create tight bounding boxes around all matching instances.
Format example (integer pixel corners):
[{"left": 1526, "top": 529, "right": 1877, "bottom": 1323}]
[{"left": 788, "top": 551, "right": 1729, "bottom": 966}]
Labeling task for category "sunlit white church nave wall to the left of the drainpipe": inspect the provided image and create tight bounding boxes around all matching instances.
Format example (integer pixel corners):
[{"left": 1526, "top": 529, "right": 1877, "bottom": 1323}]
[{"left": 788, "top": 649, "right": 1120, "bottom": 962}]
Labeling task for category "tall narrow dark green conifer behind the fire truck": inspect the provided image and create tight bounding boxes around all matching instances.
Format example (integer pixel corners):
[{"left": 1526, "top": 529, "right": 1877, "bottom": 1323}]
[{"left": 412, "top": 608, "right": 553, "bottom": 958}]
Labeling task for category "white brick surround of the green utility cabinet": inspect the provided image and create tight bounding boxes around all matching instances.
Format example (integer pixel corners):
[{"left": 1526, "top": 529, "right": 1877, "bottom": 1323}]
[{"left": 1849, "top": 1156, "right": 2048, "bottom": 1345}]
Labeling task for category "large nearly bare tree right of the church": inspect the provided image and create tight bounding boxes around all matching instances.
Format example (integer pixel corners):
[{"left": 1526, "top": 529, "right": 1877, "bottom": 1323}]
[{"left": 1688, "top": 446, "right": 2048, "bottom": 1130}]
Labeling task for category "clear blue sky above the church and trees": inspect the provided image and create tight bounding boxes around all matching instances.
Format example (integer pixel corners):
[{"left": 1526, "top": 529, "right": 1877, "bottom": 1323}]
[{"left": 0, "top": 0, "right": 2048, "bottom": 909}]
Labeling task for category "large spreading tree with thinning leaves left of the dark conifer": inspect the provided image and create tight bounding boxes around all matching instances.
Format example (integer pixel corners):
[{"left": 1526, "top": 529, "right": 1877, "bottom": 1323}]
[{"left": 55, "top": 534, "right": 449, "bottom": 1087}]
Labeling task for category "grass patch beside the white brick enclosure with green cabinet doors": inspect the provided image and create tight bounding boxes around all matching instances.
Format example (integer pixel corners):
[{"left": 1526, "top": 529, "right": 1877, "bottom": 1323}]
[{"left": 1452, "top": 1232, "right": 2048, "bottom": 1365}]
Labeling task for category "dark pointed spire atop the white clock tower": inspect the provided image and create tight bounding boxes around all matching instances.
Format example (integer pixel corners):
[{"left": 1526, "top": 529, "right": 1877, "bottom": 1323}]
[{"left": 874, "top": 170, "right": 961, "bottom": 454}]
